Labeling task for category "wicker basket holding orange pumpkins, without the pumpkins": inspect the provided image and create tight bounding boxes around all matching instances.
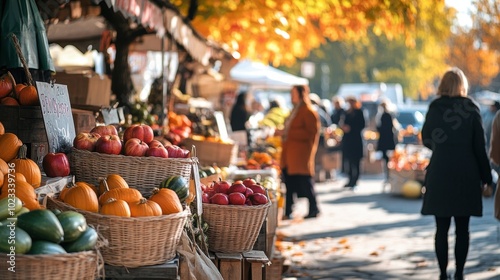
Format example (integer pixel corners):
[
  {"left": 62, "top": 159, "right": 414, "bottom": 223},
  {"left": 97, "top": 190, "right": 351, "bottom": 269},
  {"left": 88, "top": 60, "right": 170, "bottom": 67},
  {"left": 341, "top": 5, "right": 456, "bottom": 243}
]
[{"left": 47, "top": 196, "right": 189, "bottom": 268}]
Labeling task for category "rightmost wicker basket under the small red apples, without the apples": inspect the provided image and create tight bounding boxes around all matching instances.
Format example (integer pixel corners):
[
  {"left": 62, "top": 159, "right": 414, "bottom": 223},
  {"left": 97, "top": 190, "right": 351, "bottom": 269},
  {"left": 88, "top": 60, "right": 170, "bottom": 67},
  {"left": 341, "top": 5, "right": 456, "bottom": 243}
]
[{"left": 202, "top": 201, "right": 271, "bottom": 253}]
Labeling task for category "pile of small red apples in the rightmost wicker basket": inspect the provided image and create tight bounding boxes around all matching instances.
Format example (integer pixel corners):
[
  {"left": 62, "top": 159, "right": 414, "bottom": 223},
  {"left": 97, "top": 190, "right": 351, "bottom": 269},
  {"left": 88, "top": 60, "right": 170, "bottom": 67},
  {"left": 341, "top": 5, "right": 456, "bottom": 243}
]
[{"left": 201, "top": 178, "right": 268, "bottom": 206}]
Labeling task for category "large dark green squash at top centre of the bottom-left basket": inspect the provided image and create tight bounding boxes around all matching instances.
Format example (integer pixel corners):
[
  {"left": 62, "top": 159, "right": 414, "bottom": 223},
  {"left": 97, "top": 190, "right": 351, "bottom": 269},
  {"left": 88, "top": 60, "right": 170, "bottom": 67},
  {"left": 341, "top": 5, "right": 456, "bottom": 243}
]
[{"left": 17, "top": 209, "right": 64, "bottom": 243}]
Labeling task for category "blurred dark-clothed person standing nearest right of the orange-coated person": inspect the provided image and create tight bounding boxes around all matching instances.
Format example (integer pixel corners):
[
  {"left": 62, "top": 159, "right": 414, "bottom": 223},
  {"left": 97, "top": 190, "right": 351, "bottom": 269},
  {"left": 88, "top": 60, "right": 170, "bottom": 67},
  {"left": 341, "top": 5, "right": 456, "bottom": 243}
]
[{"left": 340, "top": 96, "right": 365, "bottom": 188}]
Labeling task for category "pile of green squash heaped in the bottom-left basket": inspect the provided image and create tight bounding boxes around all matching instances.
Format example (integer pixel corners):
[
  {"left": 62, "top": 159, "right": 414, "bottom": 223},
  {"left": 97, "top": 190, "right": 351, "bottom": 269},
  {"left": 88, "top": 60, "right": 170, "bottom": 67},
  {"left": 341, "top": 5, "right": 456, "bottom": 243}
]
[{"left": 0, "top": 197, "right": 98, "bottom": 255}]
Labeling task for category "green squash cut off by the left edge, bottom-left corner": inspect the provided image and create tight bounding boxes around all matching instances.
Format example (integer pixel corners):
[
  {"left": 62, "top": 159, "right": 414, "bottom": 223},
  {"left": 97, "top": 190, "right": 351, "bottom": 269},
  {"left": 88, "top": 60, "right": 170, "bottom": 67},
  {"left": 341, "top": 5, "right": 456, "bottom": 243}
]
[{"left": 0, "top": 221, "right": 32, "bottom": 254}]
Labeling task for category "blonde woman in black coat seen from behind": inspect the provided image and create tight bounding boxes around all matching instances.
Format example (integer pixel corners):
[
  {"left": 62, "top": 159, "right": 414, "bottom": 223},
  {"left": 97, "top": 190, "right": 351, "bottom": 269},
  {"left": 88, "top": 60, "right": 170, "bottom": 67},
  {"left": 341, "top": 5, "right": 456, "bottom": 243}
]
[{"left": 421, "top": 68, "right": 492, "bottom": 279}]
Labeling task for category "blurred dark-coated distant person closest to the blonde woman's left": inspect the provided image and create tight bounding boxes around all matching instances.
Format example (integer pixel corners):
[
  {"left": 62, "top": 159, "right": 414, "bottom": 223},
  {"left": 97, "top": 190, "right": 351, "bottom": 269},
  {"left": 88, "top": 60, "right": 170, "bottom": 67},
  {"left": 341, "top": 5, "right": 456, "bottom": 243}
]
[{"left": 375, "top": 100, "right": 396, "bottom": 184}]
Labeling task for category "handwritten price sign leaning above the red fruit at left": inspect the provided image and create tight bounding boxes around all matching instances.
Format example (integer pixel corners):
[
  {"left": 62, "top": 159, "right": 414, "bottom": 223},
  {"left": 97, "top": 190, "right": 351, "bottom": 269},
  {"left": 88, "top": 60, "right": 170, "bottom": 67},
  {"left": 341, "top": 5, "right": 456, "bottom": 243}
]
[{"left": 36, "top": 82, "right": 76, "bottom": 153}]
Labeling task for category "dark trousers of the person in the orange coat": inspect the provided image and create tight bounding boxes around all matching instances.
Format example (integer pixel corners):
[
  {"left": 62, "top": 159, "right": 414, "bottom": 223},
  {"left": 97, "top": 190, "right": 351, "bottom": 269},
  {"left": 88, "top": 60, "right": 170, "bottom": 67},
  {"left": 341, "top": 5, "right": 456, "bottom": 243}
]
[{"left": 282, "top": 169, "right": 319, "bottom": 216}]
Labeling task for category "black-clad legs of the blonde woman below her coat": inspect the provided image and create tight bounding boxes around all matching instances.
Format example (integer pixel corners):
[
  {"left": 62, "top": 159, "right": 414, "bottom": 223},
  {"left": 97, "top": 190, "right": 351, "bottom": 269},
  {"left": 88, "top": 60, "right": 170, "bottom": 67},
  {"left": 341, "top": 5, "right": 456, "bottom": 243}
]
[{"left": 434, "top": 217, "right": 470, "bottom": 276}]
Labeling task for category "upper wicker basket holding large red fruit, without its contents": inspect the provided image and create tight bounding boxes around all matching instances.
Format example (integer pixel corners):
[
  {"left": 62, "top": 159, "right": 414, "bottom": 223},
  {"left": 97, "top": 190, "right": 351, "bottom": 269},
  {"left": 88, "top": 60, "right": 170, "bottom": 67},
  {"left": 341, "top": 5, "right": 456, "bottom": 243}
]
[{"left": 70, "top": 148, "right": 197, "bottom": 194}]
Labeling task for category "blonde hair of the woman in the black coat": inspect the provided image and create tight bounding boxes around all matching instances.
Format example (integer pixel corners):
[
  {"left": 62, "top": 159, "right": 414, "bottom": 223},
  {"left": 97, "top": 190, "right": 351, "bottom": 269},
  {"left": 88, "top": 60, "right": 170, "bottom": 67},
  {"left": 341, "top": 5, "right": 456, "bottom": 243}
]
[{"left": 437, "top": 67, "right": 469, "bottom": 96}]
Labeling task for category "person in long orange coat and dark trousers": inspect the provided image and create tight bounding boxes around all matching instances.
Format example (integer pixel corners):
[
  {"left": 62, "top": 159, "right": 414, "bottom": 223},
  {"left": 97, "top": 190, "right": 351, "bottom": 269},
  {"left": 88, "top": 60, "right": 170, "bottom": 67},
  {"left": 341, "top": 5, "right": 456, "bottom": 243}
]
[{"left": 277, "top": 85, "right": 320, "bottom": 219}]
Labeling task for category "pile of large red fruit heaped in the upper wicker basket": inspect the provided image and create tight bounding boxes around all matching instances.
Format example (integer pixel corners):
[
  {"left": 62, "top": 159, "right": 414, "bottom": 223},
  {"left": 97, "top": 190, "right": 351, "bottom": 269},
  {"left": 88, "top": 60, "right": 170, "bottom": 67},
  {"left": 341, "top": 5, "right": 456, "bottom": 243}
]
[{"left": 73, "top": 124, "right": 189, "bottom": 158}]
